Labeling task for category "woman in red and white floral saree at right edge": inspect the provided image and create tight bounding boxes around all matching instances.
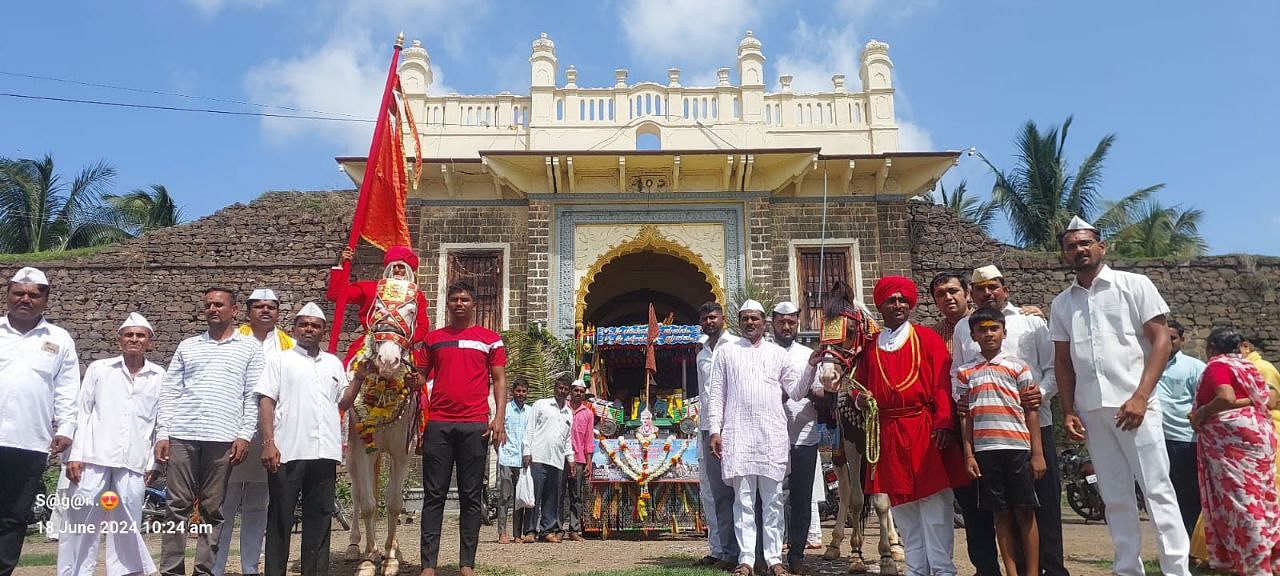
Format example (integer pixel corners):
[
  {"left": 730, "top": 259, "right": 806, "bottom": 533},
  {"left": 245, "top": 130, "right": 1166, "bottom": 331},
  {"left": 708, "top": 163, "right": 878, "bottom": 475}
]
[{"left": 1190, "top": 328, "right": 1280, "bottom": 575}]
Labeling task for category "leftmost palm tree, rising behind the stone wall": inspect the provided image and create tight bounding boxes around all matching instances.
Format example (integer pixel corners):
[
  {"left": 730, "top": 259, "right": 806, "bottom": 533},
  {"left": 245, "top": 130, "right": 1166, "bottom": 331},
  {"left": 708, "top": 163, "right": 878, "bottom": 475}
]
[{"left": 0, "top": 155, "right": 127, "bottom": 252}]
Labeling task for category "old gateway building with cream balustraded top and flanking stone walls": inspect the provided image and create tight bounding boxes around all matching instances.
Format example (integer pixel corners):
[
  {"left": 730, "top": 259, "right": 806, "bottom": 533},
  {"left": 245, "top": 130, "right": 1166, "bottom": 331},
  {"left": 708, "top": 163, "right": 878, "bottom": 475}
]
[{"left": 12, "top": 35, "right": 1280, "bottom": 364}]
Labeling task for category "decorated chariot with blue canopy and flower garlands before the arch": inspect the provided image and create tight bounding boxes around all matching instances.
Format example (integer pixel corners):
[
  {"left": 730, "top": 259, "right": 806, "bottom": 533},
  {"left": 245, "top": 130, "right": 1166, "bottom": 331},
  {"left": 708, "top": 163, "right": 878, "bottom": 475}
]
[{"left": 579, "top": 324, "right": 704, "bottom": 538}]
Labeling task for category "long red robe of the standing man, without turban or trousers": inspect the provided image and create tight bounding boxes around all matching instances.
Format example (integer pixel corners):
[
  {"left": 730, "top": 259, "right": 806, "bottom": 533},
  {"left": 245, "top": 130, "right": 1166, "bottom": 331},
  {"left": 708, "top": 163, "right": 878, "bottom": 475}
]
[{"left": 854, "top": 323, "right": 969, "bottom": 506}]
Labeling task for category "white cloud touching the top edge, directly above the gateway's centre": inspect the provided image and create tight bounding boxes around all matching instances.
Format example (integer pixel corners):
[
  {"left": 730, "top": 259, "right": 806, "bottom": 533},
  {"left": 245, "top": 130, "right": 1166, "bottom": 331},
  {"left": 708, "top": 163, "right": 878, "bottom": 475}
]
[{"left": 618, "top": 0, "right": 763, "bottom": 71}]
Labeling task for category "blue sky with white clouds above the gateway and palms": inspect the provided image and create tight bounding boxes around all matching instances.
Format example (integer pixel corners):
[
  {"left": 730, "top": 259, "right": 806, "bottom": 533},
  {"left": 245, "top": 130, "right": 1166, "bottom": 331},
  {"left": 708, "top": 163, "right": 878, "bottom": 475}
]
[{"left": 0, "top": 0, "right": 1280, "bottom": 255}]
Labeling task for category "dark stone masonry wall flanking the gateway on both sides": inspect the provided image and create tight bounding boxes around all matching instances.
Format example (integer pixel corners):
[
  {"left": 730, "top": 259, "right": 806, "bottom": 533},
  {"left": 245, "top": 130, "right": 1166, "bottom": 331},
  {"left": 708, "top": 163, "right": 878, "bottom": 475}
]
[{"left": 0, "top": 191, "right": 1280, "bottom": 365}]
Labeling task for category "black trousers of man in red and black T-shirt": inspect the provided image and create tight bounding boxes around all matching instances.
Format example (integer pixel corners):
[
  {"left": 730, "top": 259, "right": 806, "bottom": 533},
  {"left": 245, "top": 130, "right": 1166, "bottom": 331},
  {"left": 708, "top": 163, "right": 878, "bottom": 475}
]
[{"left": 421, "top": 421, "right": 489, "bottom": 568}]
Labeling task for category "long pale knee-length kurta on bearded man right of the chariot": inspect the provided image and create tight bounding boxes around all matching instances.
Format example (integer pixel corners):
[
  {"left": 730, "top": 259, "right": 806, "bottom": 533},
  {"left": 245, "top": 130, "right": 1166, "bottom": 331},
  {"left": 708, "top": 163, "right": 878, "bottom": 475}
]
[{"left": 707, "top": 338, "right": 814, "bottom": 483}]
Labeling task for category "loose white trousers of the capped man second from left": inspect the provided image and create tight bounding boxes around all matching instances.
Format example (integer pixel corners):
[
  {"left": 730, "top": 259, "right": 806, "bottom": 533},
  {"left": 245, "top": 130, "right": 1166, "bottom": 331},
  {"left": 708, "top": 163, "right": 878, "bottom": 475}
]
[{"left": 58, "top": 463, "right": 156, "bottom": 576}]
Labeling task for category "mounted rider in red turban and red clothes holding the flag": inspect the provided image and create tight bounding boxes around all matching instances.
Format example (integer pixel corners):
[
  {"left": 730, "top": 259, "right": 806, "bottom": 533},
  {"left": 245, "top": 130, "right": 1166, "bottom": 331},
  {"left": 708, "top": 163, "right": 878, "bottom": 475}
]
[{"left": 325, "top": 246, "right": 431, "bottom": 366}]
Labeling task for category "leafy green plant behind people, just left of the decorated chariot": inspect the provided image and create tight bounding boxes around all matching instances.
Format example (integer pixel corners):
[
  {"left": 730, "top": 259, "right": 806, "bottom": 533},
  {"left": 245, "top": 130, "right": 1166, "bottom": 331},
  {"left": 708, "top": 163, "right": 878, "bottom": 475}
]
[{"left": 502, "top": 323, "right": 575, "bottom": 401}]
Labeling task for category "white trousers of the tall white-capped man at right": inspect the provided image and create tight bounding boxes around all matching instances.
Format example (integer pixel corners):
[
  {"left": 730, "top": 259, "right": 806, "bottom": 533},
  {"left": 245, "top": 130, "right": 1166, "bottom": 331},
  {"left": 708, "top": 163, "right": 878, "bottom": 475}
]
[{"left": 1080, "top": 408, "right": 1190, "bottom": 576}]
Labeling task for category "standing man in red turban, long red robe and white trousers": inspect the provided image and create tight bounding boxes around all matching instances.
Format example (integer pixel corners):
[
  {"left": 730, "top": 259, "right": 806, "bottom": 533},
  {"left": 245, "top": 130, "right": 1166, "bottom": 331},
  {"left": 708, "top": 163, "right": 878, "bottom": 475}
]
[{"left": 852, "top": 276, "right": 969, "bottom": 576}]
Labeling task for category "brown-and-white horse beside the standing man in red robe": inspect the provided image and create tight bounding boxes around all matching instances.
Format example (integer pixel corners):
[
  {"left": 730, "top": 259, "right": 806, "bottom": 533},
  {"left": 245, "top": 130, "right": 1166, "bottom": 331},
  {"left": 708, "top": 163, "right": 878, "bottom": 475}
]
[{"left": 818, "top": 282, "right": 905, "bottom": 575}]
